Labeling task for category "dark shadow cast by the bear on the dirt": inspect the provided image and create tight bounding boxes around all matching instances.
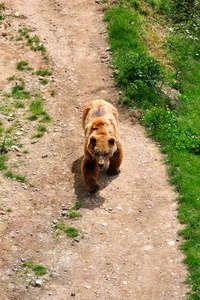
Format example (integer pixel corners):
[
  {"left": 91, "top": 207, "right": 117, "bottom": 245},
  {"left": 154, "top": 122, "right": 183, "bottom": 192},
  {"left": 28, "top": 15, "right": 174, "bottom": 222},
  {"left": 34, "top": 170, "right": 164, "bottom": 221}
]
[{"left": 72, "top": 156, "right": 116, "bottom": 210}]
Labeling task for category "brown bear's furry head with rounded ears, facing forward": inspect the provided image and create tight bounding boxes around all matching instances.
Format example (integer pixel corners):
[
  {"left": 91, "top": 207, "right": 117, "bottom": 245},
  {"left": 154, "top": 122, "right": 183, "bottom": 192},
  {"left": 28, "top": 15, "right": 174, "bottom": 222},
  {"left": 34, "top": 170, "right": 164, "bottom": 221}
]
[{"left": 87, "top": 134, "right": 117, "bottom": 169}]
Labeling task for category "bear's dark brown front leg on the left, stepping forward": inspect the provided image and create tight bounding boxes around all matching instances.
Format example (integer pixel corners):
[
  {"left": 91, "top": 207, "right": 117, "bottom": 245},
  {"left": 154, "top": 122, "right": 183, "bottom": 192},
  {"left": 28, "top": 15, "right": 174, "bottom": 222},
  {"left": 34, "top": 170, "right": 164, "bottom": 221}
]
[{"left": 81, "top": 158, "right": 99, "bottom": 194}]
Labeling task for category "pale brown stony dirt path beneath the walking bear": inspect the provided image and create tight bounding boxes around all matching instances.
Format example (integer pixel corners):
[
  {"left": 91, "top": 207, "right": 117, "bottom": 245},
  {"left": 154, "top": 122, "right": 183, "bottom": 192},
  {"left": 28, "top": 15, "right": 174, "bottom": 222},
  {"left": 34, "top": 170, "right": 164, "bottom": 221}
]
[{"left": 0, "top": 0, "right": 187, "bottom": 300}]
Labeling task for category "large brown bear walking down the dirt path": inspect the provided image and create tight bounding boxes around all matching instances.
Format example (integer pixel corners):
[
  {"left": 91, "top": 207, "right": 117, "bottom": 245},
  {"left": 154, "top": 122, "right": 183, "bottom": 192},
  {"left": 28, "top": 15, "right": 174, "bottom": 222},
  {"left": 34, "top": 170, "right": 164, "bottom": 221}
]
[{"left": 81, "top": 100, "right": 124, "bottom": 193}]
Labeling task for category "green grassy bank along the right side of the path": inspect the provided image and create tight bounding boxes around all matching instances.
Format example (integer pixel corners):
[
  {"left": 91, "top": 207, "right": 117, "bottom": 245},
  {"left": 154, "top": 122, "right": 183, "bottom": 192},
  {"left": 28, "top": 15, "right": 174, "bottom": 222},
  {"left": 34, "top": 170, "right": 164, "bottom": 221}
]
[{"left": 104, "top": 0, "right": 200, "bottom": 299}]
